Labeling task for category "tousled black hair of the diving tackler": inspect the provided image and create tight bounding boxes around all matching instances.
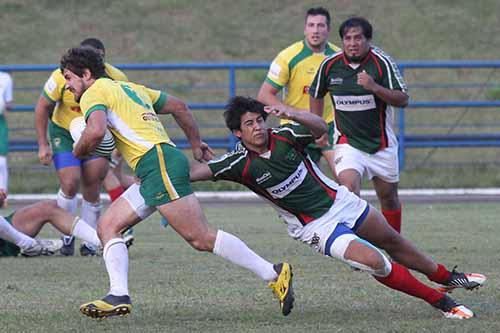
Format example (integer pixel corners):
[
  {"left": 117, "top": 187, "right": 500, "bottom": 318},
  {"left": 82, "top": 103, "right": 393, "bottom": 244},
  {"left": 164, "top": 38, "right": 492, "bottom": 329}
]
[{"left": 224, "top": 96, "right": 268, "bottom": 131}]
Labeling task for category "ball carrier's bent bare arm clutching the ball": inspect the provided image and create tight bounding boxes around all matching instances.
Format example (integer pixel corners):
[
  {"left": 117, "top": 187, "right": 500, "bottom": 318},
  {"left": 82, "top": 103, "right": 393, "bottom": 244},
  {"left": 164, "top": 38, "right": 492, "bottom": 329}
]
[{"left": 73, "top": 110, "right": 107, "bottom": 158}]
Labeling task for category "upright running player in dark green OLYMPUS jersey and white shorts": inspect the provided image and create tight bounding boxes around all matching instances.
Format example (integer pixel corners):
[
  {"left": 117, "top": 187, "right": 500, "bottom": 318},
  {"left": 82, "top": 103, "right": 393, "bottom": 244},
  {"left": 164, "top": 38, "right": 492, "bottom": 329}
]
[{"left": 310, "top": 17, "right": 408, "bottom": 232}]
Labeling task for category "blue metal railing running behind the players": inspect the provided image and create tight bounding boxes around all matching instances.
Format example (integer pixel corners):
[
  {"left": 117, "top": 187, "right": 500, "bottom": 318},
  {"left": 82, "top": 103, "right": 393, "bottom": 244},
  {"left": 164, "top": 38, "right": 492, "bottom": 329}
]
[{"left": 0, "top": 60, "right": 500, "bottom": 168}]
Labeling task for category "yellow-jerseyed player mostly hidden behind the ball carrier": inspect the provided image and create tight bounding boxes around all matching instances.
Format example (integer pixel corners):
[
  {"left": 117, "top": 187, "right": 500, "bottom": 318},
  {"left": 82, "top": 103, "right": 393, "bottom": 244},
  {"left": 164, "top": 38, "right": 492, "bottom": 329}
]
[{"left": 35, "top": 38, "right": 127, "bottom": 255}]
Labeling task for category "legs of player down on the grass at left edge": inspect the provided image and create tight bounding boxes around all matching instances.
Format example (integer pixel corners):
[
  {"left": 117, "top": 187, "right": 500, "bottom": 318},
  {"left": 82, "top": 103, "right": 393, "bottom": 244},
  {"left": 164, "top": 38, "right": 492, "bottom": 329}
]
[{"left": 0, "top": 191, "right": 101, "bottom": 257}]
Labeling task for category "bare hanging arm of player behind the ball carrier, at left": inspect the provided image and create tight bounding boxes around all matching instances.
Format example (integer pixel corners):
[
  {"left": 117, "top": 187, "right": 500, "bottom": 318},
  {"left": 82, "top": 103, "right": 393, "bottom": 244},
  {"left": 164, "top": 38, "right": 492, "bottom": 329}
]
[{"left": 35, "top": 95, "right": 55, "bottom": 165}]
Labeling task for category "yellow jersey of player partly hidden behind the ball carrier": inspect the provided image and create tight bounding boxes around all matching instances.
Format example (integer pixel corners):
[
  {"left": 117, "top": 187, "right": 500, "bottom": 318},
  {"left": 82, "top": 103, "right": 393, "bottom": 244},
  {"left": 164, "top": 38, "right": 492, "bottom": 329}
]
[{"left": 42, "top": 63, "right": 128, "bottom": 130}]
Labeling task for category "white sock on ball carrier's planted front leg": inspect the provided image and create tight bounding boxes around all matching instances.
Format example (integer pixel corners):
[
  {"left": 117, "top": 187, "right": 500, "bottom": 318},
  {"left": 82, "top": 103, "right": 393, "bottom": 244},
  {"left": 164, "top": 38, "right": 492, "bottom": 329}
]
[{"left": 102, "top": 238, "right": 128, "bottom": 296}]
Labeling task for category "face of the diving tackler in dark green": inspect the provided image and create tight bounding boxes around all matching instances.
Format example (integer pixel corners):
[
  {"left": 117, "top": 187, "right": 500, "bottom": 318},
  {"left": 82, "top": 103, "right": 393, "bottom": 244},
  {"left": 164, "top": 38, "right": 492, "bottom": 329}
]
[{"left": 234, "top": 112, "right": 267, "bottom": 153}]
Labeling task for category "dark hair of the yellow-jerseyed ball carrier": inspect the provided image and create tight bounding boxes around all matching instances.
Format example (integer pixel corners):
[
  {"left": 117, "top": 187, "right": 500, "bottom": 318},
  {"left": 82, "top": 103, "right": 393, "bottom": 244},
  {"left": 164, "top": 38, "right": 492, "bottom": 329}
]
[{"left": 60, "top": 47, "right": 106, "bottom": 79}]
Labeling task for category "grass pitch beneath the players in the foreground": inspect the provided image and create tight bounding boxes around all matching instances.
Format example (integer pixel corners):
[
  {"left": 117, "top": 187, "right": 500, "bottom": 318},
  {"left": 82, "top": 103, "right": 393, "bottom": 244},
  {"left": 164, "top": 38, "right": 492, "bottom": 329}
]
[{"left": 0, "top": 203, "right": 500, "bottom": 332}]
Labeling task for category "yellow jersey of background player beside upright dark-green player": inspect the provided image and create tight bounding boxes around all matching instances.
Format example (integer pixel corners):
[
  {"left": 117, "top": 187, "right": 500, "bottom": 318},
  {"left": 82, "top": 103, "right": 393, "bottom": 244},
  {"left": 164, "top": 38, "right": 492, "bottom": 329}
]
[{"left": 266, "top": 41, "right": 340, "bottom": 124}]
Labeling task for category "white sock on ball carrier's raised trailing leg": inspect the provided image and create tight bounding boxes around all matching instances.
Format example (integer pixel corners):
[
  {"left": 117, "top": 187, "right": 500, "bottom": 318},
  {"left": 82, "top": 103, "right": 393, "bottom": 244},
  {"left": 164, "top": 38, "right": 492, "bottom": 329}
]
[{"left": 213, "top": 230, "right": 278, "bottom": 281}]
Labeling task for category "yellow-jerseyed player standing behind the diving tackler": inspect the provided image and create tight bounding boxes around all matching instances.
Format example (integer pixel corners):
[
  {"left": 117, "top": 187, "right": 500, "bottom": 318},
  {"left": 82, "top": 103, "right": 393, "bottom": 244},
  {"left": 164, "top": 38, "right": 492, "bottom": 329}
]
[{"left": 257, "top": 7, "right": 340, "bottom": 177}]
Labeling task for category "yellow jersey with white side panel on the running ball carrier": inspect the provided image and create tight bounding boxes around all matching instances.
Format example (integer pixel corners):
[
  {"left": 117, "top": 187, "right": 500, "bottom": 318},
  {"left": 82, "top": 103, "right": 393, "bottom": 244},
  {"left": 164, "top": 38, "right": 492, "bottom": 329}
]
[{"left": 80, "top": 78, "right": 171, "bottom": 170}]
